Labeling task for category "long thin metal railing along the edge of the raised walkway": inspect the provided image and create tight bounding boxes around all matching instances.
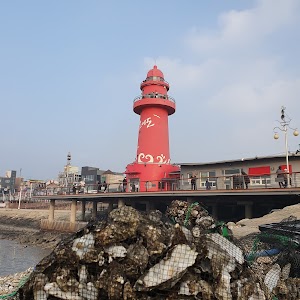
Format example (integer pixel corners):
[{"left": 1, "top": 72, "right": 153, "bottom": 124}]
[{"left": 12, "top": 172, "right": 300, "bottom": 202}]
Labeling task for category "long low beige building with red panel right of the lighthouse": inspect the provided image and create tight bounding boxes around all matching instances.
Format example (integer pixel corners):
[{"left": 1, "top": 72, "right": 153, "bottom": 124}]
[{"left": 179, "top": 153, "right": 300, "bottom": 190}]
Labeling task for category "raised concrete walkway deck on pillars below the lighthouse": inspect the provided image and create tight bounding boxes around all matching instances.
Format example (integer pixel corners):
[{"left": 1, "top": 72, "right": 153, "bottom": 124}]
[{"left": 33, "top": 188, "right": 300, "bottom": 231}]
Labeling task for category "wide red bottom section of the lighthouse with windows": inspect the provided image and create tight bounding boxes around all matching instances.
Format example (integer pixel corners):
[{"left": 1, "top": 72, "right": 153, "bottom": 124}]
[{"left": 125, "top": 163, "right": 180, "bottom": 192}]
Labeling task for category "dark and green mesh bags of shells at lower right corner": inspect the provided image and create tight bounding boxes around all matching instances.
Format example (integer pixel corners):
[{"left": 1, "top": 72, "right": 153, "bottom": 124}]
[{"left": 236, "top": 216, "right": 300, "bottom": 299}]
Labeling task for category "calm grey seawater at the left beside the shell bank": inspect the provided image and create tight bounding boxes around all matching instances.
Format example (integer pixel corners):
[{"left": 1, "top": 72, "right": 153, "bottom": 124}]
[{"left": 0, "top": 239, "right": 51, "bottom": 277}]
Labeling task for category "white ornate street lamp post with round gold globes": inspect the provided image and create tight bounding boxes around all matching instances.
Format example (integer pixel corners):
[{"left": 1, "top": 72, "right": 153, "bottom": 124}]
[{"left": 273, "top": 106, "right": 299, "bottom": 187}]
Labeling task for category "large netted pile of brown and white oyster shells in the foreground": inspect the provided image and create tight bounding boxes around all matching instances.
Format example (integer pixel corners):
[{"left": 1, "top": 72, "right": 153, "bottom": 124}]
[{"left": 20, "top": 200, "right": 300, "bottom": 300}]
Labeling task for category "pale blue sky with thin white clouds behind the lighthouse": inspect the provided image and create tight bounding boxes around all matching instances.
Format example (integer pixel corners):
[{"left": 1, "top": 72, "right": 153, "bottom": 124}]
[{"left": 0, "top": 0, "right": 300, "bottom": 179}]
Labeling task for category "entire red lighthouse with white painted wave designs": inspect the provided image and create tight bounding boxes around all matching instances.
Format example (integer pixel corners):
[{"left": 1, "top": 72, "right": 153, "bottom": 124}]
[{"left": 125, "top": 66, "right": 179, "bottom": 191}]
